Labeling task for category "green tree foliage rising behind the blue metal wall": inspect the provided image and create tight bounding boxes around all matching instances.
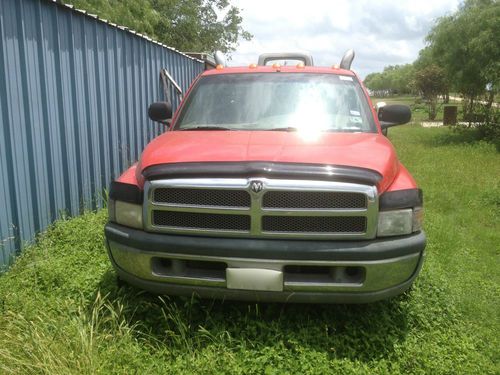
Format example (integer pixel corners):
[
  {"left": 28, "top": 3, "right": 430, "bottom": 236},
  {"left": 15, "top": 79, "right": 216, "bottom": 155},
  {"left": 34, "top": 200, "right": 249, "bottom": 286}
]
[{"left": 65, "top": 0, "right": 252, "bottom": 53}]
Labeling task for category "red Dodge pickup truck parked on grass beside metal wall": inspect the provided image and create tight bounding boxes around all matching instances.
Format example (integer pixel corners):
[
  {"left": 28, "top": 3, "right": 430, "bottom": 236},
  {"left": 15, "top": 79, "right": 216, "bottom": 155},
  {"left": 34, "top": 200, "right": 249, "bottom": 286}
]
[{"left": 105, "top": 52, "right": 426, "bottom": 303}]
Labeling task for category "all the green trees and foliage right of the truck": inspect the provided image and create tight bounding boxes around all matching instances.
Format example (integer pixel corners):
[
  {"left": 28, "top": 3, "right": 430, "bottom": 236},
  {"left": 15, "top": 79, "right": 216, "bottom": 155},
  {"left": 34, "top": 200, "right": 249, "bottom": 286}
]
[{"left": 365, "top": 0, "right": 500, "bottom": 142}]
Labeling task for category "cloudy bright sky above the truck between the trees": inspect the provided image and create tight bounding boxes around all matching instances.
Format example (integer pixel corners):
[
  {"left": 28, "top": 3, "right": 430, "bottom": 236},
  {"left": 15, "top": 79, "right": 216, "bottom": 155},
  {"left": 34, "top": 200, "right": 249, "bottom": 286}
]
[{"left": 228, "top": 0, "right": 460, "bottom": 78}]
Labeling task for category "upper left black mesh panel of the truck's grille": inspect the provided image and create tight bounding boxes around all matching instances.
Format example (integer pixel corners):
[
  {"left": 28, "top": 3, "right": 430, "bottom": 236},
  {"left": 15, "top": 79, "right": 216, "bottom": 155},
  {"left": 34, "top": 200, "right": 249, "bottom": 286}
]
[{"left": 153, "top": 188, "right": 250, "bottom": 207}]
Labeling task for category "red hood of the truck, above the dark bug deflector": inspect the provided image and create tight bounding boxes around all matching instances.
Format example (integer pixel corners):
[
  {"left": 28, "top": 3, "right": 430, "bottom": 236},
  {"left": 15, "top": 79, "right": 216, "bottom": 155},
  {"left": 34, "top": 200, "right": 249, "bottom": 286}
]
[{"left": 136, "top": 131, "right": 399, "bottom": 192}]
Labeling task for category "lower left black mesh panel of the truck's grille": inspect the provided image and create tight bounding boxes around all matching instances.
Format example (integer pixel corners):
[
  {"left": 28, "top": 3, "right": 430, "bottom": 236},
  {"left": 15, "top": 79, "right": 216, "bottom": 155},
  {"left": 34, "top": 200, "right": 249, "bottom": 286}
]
[{"left": 153, "top": 210, "right": 250, "bottom": 231}]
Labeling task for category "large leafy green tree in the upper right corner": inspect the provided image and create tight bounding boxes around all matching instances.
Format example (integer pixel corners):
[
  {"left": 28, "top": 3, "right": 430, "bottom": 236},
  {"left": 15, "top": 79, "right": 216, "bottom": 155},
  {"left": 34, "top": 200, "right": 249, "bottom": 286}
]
[{"left": 426, "top": 0, "right": 500, "bottom": 114}]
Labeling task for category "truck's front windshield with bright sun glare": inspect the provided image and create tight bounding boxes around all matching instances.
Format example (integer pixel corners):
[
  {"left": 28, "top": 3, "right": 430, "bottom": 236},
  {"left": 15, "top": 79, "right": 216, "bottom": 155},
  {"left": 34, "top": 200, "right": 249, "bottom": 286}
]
[{"left": 175, "top": 73, "right": 376, "bottom": 132}]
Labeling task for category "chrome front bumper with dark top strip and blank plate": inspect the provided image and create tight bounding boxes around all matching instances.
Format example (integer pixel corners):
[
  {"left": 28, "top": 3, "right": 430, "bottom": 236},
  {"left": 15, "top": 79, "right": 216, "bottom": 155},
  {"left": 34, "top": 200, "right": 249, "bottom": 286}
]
[{"left": 105, "top": 223, "right": 426, "bottom": 303}]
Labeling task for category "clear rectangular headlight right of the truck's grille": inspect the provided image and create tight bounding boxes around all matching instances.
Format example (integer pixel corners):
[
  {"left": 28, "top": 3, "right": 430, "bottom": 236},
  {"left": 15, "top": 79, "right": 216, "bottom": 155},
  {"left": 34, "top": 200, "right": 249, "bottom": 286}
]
[{"left": 377, "top": 207, "right": 423, "bottom": 237}]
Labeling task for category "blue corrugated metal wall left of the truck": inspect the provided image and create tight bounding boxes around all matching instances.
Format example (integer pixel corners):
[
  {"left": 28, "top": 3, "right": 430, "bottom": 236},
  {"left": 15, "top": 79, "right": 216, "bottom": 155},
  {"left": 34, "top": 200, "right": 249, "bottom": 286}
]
[{"left": 0, "top": 0, "right": 203, "bottom": 267}]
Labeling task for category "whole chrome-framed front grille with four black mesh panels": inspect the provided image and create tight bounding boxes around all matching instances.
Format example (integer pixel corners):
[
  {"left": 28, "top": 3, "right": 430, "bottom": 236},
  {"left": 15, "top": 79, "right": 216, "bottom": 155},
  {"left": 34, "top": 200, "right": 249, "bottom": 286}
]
[{"left": 145, "top": 177, "right": 378, "bottom": 240}]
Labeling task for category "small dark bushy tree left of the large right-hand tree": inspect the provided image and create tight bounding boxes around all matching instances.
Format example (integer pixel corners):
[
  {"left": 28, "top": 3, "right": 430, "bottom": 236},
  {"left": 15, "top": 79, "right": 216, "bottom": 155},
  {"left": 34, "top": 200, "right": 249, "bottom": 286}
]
[{"left": 415, "top": 64, "right": 448, "bottom": 121}]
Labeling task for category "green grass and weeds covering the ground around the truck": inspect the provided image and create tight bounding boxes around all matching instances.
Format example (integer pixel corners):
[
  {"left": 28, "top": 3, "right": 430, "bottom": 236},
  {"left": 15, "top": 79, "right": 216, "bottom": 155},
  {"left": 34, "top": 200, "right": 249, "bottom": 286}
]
[{"left": 0, "top": 125, "right": 500, "bottom": 374}]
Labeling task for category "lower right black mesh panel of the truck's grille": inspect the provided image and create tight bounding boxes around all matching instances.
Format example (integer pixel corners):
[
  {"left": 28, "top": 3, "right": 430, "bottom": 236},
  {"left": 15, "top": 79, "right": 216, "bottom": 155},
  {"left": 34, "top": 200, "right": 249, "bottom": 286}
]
[{"left": 262, "top": 216, "right": 366, "bottom": 233}]
